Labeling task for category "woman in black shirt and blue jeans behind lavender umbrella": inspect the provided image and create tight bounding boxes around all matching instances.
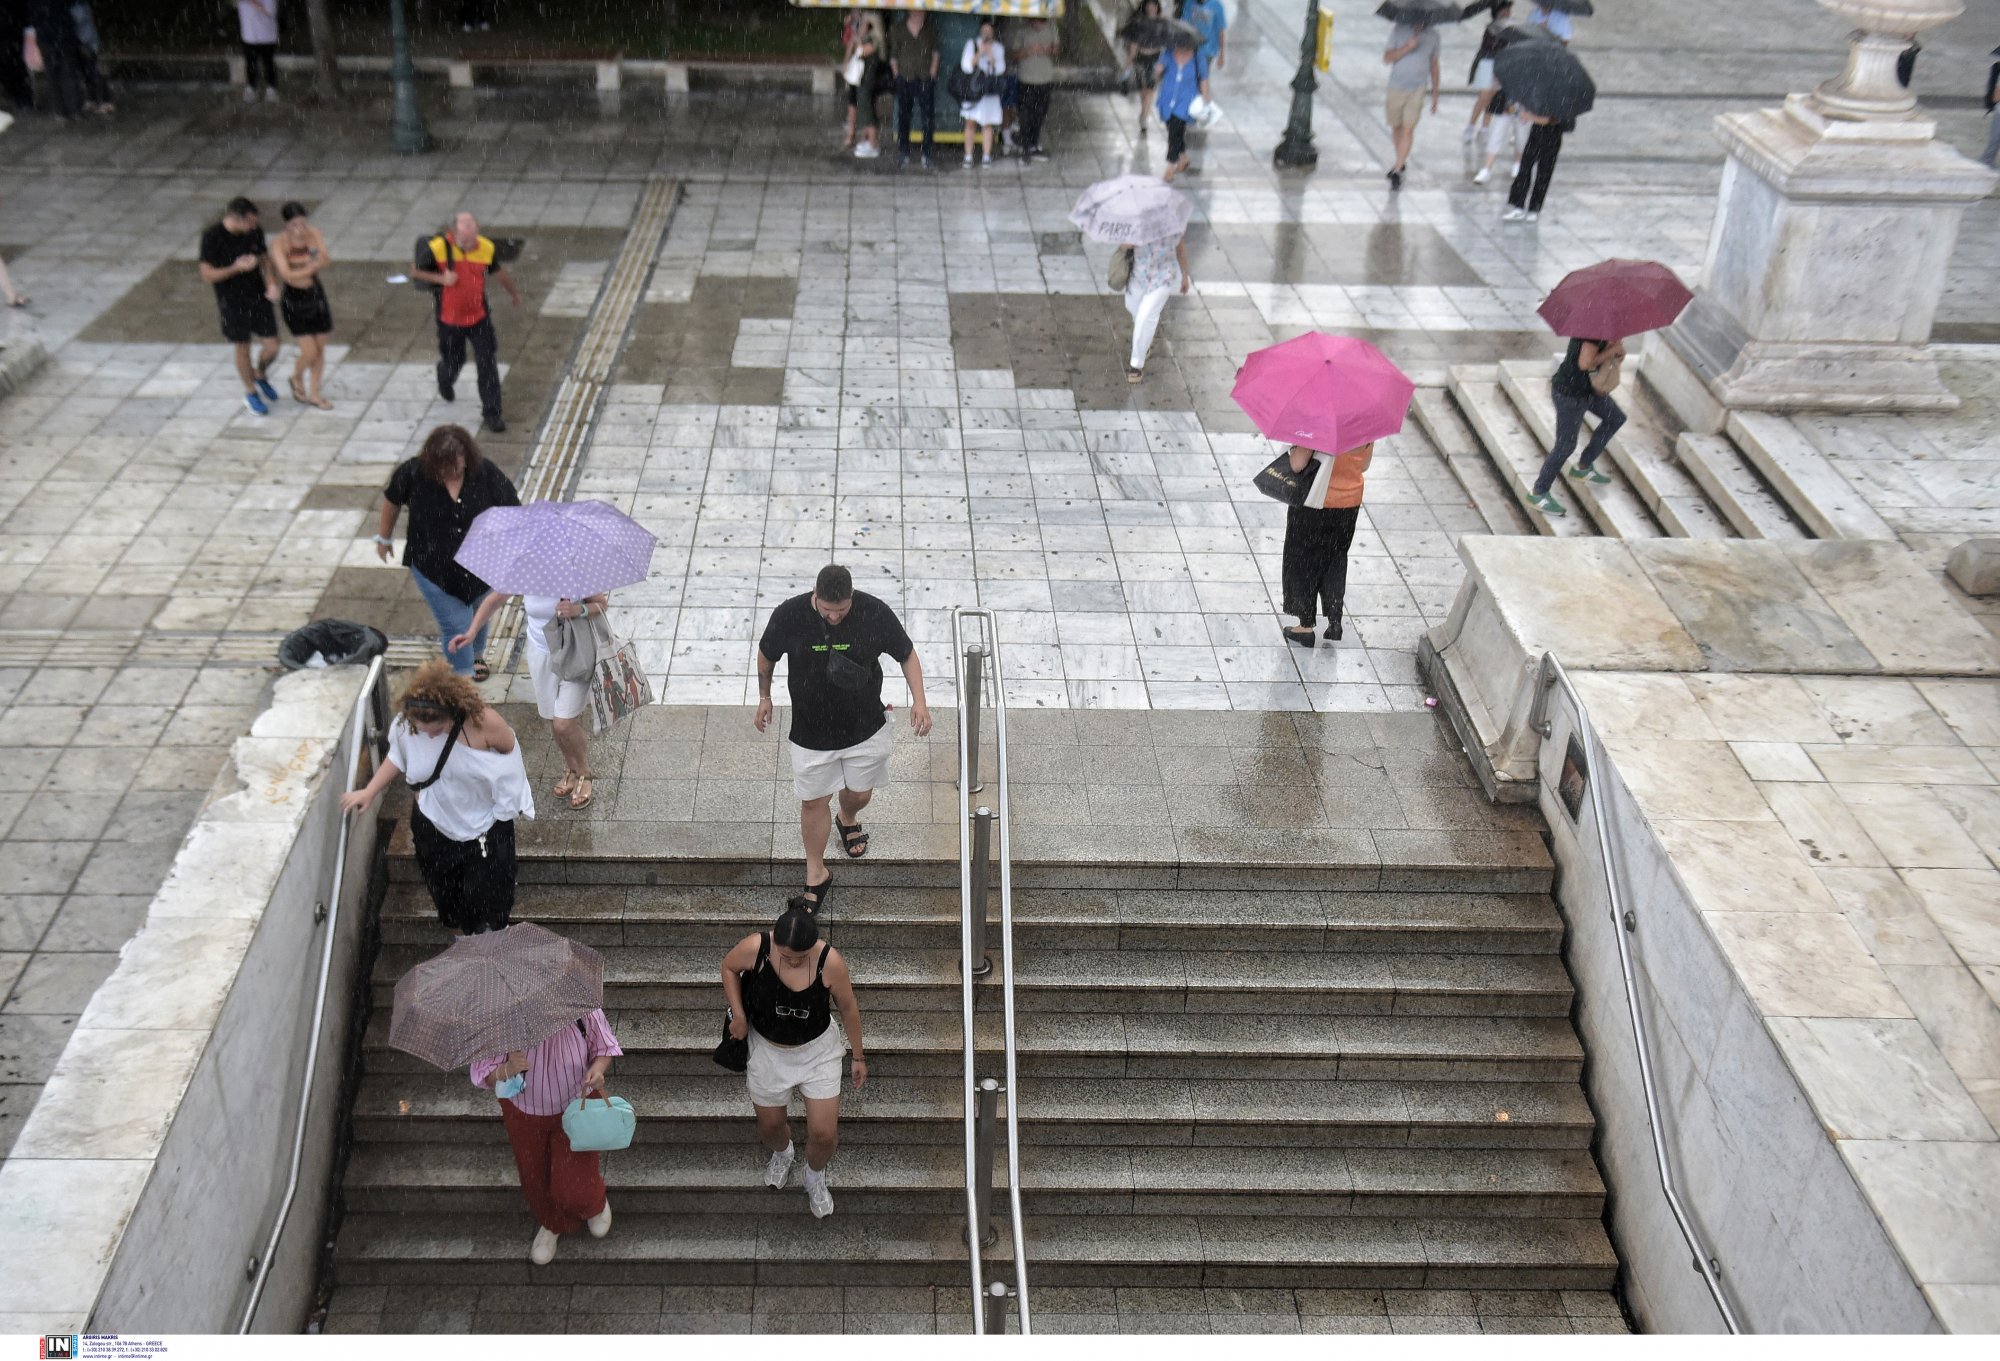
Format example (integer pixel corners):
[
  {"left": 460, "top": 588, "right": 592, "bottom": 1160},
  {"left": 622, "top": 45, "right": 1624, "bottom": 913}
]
[{"left": 376, "top": 426, "right": 520, "bottom": 681}]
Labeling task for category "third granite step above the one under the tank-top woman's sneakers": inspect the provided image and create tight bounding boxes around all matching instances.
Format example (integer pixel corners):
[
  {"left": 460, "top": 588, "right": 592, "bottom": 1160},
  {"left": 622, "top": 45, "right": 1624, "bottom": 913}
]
[{"left": 372, "top": 952, "right": 1572, "bottom": 1017}]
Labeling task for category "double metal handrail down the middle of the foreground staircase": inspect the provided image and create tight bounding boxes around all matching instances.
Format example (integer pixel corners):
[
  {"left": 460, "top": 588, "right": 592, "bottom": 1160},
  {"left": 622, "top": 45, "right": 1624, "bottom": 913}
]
[{"left": 952, "top": 606, "right": 1032, "bottom": 1337}]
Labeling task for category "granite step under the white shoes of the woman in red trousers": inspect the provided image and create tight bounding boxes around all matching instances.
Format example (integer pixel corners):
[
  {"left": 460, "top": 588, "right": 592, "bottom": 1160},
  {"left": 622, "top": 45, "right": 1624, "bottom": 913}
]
[{"left": 334, "top": 1208, "right": 1618, "bottom": 1291}]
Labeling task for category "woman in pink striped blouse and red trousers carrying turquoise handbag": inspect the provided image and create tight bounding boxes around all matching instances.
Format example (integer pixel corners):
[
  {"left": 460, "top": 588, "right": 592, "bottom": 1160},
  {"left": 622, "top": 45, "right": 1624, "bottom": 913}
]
[{"left": 472, "top": 1011, "right": 624, "bottom": 1267}]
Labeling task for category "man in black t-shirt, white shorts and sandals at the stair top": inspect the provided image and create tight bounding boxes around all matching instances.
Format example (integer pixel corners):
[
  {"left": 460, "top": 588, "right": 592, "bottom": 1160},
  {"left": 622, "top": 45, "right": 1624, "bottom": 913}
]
[{"left": 756, "top": 566, "right": 930, "bottom": 909}]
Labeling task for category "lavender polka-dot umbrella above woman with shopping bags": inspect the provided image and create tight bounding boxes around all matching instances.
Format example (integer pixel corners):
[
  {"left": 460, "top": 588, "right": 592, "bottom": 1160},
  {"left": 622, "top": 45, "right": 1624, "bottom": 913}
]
[{"left": 452, "top": 500, "right": 658, "bottom": 600}]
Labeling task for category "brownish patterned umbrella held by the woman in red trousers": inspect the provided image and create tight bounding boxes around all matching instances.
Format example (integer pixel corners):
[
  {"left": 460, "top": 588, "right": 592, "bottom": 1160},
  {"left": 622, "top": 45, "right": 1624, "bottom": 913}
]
[{"left": 388, "top": 923, "right": 604, "bottom": 1069}]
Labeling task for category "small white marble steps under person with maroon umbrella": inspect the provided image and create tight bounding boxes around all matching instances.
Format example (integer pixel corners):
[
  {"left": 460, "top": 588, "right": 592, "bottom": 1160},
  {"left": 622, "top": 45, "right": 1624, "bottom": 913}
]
[{"left": 1412, "top": 350, "right": 1896, "bottom": 538}]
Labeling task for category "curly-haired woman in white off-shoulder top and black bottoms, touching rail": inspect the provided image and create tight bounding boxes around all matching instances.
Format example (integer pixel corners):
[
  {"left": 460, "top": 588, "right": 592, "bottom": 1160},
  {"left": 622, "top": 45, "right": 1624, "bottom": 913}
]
[{"left": 340, "top": 658, "right": 534, "bottom": 935}]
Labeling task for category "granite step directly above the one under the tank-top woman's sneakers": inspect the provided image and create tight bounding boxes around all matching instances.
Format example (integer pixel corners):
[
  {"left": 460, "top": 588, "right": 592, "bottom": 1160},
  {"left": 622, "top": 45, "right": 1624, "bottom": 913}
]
[{"left": 354, "top": 1072, "right": 1596, "bottom": 1149}]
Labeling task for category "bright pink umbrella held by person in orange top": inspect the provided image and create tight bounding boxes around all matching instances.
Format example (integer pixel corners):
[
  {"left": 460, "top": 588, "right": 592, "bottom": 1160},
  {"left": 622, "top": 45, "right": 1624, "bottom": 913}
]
[{"left": 1230, "top": 330, "right": 1416, "bottom": 454}]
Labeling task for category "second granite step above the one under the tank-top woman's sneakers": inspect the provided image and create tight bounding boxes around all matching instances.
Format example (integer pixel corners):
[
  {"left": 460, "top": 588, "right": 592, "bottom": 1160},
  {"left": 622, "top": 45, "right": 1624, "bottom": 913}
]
[{"left": 362, "top": 1004, "right": 1584, "bottom": 1083}]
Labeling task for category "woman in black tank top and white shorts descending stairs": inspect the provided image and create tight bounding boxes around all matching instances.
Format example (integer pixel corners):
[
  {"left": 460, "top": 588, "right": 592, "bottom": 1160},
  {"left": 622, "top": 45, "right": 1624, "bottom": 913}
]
[{"left": 722, "top": 897, "right": 868, "bottom": 1219}]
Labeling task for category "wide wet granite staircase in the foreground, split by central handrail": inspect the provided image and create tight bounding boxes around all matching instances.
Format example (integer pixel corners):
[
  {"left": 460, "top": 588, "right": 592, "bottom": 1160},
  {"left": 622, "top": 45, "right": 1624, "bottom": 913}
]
[{"left": 320, "top": 843, "right": 1618, "bottom": 1307}]
